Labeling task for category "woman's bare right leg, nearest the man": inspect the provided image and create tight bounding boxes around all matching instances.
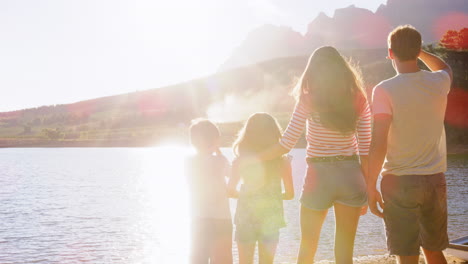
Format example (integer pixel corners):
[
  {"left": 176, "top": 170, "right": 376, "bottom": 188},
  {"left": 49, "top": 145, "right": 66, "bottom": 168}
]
[{"left": 334, "top": 203, "right": 361, "bottom": 264}]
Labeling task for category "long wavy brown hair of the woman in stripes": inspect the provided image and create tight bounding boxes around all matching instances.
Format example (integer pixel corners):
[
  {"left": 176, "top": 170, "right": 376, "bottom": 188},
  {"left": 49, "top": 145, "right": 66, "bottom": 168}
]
[{"left": 293, "top": 46, "right": 366, "bottom": 134}]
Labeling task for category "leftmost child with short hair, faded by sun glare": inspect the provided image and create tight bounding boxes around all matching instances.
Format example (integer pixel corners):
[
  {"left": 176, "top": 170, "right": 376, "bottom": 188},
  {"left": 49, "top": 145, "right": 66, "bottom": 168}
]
[{"left": 186, "top": 120, "right": 232, "bottom": 264}]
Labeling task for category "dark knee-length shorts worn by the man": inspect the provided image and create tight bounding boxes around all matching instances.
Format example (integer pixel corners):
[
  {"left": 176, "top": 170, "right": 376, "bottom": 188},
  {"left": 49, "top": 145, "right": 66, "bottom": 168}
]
[{"left": 381, "top": 173, "right": 448, "bottom": 256}]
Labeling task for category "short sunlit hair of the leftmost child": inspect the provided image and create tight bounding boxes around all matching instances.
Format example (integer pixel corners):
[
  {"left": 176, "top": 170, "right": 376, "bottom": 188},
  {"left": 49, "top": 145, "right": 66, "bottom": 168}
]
[{"left": 189, "top": 118, "right": 220, "bottom": 148}]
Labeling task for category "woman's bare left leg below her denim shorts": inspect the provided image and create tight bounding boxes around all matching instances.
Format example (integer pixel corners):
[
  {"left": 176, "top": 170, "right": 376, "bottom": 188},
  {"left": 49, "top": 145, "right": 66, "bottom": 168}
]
[{"left": 297, "top": 206, "right": 328, "bottom": 264}]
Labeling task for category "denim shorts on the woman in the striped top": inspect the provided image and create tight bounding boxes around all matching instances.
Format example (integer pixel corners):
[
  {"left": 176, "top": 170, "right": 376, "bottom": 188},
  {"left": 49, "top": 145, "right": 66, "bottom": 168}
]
[{"left": 301, "top": 160, "right": 367, "bottom": 211}]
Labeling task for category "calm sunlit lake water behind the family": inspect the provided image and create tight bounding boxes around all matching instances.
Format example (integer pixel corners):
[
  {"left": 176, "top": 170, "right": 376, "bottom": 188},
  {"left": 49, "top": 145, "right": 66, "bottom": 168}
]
[{"left": 0, "top": 147, "right": 468, "bottom": 264}]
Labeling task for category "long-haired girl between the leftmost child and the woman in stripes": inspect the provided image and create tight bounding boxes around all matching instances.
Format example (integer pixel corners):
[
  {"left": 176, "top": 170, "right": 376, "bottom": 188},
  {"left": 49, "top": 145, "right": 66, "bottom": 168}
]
[{"left": 228, "top": 113, "right": 294, "bottom": 264}]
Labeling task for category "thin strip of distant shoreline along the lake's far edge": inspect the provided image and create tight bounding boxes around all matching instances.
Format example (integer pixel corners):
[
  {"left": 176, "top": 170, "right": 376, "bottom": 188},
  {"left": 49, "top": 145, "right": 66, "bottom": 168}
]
[{"left": 0, "top": 139, "right": 468, "bottom": 155}]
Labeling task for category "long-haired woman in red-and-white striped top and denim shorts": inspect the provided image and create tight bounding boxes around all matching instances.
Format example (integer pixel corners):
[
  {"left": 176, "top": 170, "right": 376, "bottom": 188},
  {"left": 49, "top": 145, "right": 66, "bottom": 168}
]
[{"left": 257, "top": 47, "right": 371, "bottom": 264}]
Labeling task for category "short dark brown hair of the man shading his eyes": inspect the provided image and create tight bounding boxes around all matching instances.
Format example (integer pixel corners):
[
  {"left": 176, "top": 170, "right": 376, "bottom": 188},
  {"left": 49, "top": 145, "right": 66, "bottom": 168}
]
[{"left": 388, "top": 25, "right": 422, "bottom": 61}]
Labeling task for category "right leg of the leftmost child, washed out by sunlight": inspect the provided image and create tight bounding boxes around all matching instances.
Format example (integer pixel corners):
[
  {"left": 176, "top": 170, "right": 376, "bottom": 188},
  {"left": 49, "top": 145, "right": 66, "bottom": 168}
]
[{"left": 210, "top": 220, "right": 232, "bottom": 264}]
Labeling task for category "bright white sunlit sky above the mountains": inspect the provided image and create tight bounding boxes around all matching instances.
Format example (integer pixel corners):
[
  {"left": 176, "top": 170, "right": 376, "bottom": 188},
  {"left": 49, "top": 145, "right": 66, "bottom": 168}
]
[{"left": 0, "top": 0, "right": 386, "bottom": 112}]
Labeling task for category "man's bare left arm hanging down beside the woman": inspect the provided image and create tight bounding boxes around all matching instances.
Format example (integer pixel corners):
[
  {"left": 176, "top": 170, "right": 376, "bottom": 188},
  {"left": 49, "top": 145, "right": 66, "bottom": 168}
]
[{"left": 366, "top": 114, "right": 392, "bottom": 217}]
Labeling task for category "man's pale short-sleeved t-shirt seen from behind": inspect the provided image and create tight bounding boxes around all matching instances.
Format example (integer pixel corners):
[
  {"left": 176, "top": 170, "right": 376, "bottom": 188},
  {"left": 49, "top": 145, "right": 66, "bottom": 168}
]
[{"left": 372, "top": 70, "right": 450, "bottom": 175}]
